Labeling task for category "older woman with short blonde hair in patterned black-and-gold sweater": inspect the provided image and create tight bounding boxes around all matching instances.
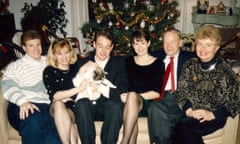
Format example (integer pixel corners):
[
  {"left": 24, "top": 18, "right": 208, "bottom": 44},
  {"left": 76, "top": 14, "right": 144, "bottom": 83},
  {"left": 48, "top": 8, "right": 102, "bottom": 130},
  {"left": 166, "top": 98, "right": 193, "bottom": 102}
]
[{"left": 172, "top": 25, "right": 240, "bottom": 144}]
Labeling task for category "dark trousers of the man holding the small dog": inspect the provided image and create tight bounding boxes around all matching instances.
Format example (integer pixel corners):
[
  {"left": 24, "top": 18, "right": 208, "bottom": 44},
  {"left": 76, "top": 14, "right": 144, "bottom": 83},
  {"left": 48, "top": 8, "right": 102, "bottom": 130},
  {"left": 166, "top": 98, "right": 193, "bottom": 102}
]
[{"left": 74, "top": 97, "right": 123, "bottom": 144}]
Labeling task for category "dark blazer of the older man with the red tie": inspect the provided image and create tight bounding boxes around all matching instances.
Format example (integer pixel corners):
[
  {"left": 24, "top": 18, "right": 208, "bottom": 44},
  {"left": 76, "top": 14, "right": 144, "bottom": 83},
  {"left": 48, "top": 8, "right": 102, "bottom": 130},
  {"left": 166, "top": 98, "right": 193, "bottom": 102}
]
[{"left": 152, "top": 49, "right": 196, "bottom": 79}]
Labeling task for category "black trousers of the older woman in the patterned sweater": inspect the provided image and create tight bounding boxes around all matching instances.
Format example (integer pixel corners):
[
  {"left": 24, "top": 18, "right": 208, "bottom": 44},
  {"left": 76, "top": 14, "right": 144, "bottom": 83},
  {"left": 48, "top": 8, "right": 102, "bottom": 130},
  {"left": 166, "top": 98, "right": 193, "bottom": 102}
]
[{"left": 171, "top": 117, "right": 227, "bottom": 144}]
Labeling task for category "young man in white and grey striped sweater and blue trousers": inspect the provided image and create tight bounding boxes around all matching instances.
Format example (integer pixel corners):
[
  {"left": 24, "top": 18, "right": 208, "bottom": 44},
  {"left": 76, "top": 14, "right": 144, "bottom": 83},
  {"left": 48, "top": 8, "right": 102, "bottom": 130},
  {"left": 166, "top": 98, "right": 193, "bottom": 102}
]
[{"left": 1, "top": 30, "right": 60, "bottom": 144}]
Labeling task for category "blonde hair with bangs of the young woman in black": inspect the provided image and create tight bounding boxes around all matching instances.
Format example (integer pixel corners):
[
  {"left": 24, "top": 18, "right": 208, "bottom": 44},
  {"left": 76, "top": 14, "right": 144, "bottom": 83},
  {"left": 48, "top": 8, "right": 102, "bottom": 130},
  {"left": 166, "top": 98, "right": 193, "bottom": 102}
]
[{"left": 47, "top": 38, "right": 77, "bottom": 67}]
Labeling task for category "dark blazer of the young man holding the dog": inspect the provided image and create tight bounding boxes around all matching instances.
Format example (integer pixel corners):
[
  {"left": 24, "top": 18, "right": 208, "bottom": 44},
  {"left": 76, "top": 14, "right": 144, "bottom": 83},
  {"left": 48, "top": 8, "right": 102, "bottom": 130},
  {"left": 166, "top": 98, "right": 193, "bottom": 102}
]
[{"left": 79, "top": 53, "right": 128, "bottom": 102}]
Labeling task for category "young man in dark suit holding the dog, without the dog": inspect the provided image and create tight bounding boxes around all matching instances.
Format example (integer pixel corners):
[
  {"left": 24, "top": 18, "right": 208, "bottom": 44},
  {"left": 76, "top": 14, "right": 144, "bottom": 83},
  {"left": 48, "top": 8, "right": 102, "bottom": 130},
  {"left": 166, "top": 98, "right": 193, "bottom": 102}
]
[{"left": 74, "top": 30, "right": 128, "bottom": 144}]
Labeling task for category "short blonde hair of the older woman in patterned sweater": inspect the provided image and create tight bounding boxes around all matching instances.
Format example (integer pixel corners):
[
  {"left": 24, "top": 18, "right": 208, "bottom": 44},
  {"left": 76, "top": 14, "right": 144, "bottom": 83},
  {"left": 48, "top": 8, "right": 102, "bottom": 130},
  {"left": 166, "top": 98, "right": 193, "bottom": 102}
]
[{"left": 195, "top": 25, "right": 222, "bottom": 46}]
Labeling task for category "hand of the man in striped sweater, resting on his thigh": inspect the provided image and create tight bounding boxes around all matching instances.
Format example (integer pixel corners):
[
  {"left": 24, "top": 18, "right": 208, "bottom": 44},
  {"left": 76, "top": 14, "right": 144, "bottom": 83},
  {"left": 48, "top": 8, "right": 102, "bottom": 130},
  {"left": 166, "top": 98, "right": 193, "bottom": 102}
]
[{"left": 19, "top": 102, "right": 40, "bottom": 120}]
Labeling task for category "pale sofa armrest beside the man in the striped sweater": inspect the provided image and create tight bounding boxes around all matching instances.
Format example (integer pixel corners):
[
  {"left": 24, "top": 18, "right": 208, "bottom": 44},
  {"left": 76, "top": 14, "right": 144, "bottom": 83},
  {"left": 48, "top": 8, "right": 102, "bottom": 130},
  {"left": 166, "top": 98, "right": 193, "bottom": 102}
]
[{"left": 0, "top": 84, "right": 9, "bottom": 144}]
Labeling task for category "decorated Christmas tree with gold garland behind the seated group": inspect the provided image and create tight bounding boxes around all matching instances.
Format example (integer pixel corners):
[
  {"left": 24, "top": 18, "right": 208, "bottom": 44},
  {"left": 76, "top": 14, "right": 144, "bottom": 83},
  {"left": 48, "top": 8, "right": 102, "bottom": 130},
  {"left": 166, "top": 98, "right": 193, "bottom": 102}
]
[{"left": 81, "top": 0, "right": 179, "bottom": 55}]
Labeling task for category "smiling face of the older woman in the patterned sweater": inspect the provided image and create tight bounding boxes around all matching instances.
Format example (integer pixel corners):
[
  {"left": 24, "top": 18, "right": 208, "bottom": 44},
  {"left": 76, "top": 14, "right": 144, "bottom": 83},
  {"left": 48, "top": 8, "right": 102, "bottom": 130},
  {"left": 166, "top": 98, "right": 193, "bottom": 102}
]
[{"left": 196, "top": 38, "right": 219, "bottom": 62}]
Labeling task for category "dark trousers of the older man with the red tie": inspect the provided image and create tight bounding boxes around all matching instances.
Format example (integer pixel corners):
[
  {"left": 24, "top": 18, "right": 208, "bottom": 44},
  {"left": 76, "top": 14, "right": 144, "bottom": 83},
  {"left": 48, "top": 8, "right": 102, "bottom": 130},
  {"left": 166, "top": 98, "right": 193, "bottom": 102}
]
[{"left": 148, "top": 91, "right": 183, "bottom": 144}]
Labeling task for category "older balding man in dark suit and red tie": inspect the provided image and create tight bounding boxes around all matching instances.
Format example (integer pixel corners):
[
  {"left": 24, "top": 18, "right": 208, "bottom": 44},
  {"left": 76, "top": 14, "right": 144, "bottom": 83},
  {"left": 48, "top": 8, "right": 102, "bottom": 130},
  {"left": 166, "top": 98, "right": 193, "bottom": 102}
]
[{"left": 148, "top": 29, "right": 194, "bottom": 144}]
